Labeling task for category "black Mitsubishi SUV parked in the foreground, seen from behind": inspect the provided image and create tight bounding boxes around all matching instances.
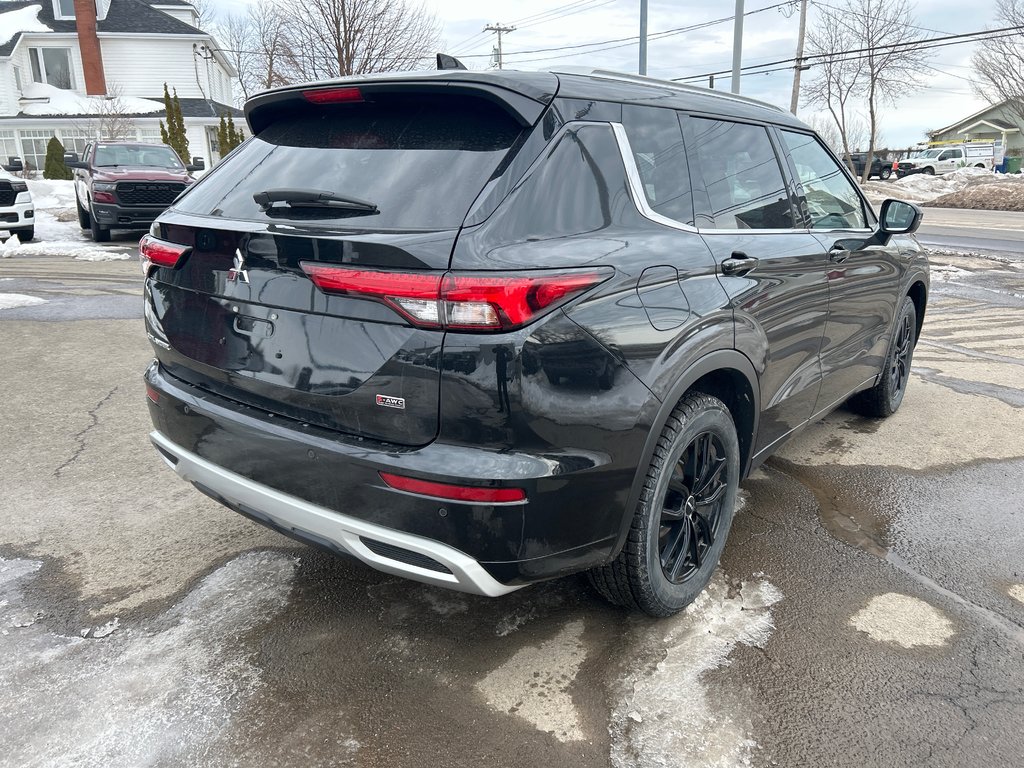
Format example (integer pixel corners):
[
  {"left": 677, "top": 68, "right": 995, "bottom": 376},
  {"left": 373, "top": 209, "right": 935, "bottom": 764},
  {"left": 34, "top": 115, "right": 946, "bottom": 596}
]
[{"left": 140, "top": 71, "right": 929, "bottom": 615}]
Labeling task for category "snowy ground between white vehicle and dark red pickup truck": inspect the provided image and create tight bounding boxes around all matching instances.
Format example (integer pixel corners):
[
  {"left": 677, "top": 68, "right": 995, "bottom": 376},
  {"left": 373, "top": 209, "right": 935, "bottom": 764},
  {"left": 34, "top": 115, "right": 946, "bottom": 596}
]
[{"left": 0, "top": 180, "right": 138, "bottom": 261}]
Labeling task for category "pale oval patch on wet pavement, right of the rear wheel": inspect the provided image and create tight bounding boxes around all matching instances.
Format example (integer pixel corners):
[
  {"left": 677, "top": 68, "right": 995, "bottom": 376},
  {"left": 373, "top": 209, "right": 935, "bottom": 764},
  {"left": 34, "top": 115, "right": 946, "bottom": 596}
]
[{"left": 850, "top": 592, "right": 954, "bottom": 648}]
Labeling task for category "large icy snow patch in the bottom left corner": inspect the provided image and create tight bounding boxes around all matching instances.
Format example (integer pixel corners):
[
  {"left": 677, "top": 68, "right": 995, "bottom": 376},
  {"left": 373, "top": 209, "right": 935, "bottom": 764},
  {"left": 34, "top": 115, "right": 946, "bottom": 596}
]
[{"left": 0, "top": 552, "right": 296, "bottom": 767}]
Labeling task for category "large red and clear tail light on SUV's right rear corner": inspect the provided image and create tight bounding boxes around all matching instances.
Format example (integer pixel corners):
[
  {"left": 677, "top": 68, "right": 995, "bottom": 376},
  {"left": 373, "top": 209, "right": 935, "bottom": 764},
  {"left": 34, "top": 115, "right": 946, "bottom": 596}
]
[{"left": 300, "top": 261, "right": 611, "bottom": 331}]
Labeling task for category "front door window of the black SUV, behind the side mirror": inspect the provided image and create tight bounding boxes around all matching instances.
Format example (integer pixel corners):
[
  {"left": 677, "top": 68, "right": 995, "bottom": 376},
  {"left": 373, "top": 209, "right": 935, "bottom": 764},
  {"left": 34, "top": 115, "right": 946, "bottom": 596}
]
[{"left": 780, "top": 131, "right": 867, "bottom": 229}]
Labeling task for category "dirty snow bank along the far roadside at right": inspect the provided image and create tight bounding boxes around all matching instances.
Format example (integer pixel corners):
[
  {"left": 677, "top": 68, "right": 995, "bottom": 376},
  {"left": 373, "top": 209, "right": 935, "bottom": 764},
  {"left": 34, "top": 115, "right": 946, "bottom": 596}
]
[{"left": 863, "top": 168, "right": 1024, "bottom": 211}]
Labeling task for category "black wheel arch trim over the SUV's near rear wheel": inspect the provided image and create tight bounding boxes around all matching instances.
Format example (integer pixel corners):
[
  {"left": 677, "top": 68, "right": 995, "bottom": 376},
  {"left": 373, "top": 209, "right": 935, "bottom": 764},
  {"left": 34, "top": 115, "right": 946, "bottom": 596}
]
[{"left": 609, "top": 349, "right": 761, "bottom": 560}]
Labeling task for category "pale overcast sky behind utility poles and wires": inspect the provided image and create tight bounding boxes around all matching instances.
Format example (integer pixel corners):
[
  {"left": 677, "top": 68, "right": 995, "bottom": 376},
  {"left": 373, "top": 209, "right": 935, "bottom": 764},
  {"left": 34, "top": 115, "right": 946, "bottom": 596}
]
[{"left": 217, "top": 0, "right": 995, "bottom": 147}]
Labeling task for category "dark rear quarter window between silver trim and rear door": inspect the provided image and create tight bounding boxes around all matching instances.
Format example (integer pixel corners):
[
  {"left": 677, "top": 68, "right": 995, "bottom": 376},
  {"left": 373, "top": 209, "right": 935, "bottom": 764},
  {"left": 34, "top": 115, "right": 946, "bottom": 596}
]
[{"left": 623, "top": 105, "right": 693, "bottom": 224}]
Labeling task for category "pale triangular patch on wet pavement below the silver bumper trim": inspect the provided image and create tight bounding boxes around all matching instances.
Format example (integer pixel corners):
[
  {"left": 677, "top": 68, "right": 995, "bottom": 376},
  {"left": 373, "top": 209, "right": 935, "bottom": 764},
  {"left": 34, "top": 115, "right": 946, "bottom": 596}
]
[{"left": 476, "top": 621, "right": 587, "bottom": 741}]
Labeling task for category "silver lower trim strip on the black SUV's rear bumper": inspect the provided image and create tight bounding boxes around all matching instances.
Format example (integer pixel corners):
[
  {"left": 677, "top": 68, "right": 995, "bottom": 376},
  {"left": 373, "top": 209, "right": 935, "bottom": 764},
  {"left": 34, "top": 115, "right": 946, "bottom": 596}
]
[{"left": 150, "top": 431, "right": 519, "bottom": 597}]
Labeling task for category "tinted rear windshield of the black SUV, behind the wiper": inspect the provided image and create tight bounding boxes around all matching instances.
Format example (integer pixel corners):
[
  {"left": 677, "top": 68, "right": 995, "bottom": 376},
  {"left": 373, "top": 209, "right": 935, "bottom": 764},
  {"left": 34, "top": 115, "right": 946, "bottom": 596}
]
[{"left": 175, "top": 94, "right": 522, "bottom": 229}]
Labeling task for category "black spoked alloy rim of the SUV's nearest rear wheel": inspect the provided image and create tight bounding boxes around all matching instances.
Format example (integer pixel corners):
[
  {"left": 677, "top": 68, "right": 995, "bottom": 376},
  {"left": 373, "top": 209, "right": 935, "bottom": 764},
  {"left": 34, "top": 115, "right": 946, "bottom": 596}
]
[{"left": 657, "top": 432, "right": 726, "bottom": 584}]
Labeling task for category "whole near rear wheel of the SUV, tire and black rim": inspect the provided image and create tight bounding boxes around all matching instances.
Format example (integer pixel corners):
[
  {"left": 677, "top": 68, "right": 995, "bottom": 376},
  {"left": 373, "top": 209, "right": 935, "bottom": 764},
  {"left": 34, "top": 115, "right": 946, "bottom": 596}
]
[{"left": 587, "top": 392, "right": 739, "bottom": 616}]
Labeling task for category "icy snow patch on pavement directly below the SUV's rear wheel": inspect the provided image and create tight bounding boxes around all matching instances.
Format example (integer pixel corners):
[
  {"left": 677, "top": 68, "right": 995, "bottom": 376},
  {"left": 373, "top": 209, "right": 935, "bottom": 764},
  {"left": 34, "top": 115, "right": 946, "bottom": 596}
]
[{"left": 608, "top": 571, "right": 782, "bottom": 768}]
